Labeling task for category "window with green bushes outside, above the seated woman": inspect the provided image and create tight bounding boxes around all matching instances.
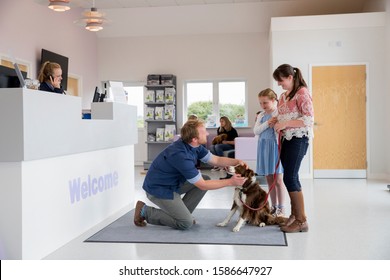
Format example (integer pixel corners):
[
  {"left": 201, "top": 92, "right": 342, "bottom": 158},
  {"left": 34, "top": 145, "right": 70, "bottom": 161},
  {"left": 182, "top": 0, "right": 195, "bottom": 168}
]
[{"left": 184, "top": 81, "right": 248, "bottom": 127}]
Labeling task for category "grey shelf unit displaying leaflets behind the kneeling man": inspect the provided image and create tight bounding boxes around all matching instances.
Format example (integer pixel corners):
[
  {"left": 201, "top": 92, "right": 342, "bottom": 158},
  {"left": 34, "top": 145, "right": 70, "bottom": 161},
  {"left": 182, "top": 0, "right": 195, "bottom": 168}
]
[{"left": 144, "top": 75, "right": 177, "bottom": 170}]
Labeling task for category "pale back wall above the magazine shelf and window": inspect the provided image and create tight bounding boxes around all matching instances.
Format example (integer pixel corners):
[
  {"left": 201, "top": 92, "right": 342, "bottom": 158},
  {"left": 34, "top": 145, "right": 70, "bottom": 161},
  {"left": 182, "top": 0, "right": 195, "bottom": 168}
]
[{"left": 98, "top": 33, "right": 270, "bottom": 128}]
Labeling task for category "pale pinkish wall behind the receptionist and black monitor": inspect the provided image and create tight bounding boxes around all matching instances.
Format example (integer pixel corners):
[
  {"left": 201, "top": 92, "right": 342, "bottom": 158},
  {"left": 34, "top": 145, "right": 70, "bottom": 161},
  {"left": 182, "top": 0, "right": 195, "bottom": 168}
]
[{"left": 0, "top": 0, "right": 99, "bottom": 108}]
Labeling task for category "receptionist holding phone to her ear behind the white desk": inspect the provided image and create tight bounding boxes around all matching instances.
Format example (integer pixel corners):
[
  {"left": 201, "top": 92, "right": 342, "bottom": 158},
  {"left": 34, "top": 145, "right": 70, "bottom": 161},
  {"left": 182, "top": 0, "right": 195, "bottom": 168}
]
[{"left": 38, "top": 61, "right": 65, "bottom": 94}]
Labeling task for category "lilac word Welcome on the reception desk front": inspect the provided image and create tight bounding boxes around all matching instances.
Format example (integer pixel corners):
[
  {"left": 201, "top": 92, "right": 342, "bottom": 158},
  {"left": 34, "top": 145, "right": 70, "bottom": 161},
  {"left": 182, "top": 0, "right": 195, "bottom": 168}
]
[{"left": 69, "top": 171, "right": 118, "bottom": 204}]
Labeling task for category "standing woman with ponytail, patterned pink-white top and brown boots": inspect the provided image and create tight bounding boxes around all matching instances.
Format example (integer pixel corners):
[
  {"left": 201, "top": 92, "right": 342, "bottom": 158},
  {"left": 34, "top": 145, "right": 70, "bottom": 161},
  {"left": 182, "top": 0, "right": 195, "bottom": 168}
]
[{"left": 273, "top": 64, "right": 314, "bottom": 232}]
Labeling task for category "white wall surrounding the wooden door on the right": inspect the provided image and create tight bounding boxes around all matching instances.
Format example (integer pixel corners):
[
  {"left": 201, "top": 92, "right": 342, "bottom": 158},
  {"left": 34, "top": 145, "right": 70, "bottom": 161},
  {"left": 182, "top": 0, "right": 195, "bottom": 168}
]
[{"left": 271, "top": 13, "right": 389, "bottom": 178}]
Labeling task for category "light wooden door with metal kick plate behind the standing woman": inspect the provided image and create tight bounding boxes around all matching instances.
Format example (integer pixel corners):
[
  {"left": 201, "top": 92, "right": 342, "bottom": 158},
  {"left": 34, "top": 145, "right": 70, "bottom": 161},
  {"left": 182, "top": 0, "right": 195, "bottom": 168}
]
[{"left": 312, "top": 65, "right": 367, "bottom": 178}]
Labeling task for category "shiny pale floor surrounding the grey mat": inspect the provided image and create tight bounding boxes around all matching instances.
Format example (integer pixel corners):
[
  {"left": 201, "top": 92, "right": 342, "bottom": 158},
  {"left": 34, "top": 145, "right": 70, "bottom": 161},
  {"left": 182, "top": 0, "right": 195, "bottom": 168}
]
[{"left": 47, "top": 167, "right": 390, "bottom": 260}]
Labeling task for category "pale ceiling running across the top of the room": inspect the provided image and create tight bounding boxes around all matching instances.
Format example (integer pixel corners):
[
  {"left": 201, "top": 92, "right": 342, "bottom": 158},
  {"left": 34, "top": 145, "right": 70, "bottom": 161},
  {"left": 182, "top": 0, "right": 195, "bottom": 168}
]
[{"left": 38, "top": 0, "right": 386, "bottom": 37}]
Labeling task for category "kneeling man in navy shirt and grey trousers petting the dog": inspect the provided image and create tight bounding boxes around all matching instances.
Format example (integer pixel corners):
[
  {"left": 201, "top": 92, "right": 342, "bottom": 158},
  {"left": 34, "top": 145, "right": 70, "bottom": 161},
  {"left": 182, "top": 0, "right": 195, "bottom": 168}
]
[{"left": 134, "top": 120, "right": 246, "bottom": 230}]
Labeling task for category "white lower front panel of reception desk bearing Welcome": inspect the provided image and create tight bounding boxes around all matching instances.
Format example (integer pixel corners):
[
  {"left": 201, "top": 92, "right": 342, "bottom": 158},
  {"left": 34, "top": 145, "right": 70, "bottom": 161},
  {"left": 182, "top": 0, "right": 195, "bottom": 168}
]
[{"left": 6, "top": 145, "right": 134, "bottom": 259}]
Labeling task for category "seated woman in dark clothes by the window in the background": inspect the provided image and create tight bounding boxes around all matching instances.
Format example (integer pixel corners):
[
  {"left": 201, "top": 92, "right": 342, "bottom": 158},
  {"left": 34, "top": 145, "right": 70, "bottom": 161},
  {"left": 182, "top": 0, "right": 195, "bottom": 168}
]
[{"left": 210, "top": 117, "right": 238, "bottom": 157}]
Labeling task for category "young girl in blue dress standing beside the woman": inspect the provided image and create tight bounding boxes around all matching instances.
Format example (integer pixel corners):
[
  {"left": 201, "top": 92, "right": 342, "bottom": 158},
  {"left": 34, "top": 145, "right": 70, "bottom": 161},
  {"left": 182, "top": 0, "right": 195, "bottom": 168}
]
[{"left": 253, "top": 88, "right": 285, "bottom": 216}]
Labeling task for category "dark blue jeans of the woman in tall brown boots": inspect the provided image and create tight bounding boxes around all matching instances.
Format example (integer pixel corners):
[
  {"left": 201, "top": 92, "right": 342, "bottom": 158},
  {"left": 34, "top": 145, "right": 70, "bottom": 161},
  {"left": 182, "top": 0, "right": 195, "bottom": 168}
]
[{"left": 280, "top": 137, "right": 309, "bottom": 192}]
